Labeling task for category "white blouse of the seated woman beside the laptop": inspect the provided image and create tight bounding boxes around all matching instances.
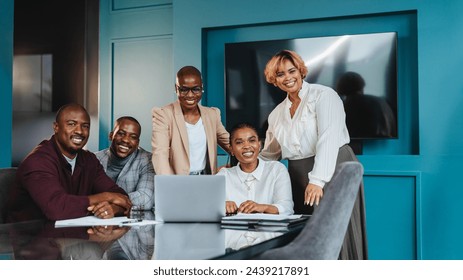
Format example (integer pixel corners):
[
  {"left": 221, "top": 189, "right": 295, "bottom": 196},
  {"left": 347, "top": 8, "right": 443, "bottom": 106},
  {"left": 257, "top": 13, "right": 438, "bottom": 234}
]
[{"left": 217, "top": 160, "right": 294, "bottom": 215}]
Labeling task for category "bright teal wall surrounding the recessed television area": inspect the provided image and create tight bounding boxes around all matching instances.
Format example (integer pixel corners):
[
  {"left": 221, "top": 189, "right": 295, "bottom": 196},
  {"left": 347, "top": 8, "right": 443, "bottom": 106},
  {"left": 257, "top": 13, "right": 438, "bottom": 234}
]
[{"left": 173, "top": 0, "right": 463, "bottom": 259}]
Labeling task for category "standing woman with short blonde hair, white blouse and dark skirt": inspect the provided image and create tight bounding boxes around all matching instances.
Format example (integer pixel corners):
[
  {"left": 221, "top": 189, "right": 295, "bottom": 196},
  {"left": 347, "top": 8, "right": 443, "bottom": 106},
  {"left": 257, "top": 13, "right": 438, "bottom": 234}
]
[{"left": 260, "top": 50, "right": 368, "bottom": 259}]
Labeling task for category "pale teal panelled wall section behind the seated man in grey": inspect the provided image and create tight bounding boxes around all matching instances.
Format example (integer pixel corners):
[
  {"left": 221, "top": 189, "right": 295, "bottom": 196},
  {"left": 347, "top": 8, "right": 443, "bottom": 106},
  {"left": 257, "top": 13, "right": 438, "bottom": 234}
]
[{"left": 99, "top": 0, "right": 175, "bottom": 150}]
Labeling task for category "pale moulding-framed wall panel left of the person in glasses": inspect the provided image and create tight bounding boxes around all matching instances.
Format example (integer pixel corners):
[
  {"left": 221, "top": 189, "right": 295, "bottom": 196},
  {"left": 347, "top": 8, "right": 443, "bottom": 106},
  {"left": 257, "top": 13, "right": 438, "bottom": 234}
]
[{"left": 112, "top": 37, "right": 175, "bottom": 151}]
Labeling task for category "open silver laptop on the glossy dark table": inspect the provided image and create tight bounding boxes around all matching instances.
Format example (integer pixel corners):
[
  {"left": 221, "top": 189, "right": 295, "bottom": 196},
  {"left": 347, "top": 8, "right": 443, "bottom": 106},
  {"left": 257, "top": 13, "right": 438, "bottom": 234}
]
[{"left": 154, "top": 175, "right": 225, "bottom": 222}]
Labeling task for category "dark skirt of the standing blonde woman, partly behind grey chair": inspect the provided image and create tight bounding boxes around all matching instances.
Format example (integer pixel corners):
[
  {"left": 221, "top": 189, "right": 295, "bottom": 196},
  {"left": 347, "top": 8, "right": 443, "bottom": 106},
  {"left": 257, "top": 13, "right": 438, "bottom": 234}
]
[{"left": 288, "top": 145, "right": 368, "bottom": 260}]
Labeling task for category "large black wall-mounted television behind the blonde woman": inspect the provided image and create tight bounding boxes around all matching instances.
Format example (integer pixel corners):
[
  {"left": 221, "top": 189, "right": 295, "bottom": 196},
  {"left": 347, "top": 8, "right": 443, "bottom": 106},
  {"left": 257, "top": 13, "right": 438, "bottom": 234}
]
[{"left": 225, "top": 32, "right": 398, "bottom": 139}]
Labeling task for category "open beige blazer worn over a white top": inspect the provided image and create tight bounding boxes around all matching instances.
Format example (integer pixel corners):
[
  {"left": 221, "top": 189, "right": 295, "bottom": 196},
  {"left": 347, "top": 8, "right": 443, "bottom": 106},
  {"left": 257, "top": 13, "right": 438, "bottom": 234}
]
[{"left": 151, "top": 101, "right": 229, "bottom": 175}]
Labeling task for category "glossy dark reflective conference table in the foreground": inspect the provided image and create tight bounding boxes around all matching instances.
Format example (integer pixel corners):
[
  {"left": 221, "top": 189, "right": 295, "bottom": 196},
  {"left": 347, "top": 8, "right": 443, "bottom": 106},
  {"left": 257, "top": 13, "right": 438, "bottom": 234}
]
[{"left": 0, "top": 212, "right": 304, "bottom": 260}]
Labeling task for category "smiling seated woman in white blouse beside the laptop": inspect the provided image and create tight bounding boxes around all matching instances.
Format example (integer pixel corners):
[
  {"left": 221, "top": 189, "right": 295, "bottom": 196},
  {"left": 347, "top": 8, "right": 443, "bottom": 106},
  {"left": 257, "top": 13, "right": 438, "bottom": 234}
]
[{"left": 217, "top": 123, "right": 294, "bottom": 215}]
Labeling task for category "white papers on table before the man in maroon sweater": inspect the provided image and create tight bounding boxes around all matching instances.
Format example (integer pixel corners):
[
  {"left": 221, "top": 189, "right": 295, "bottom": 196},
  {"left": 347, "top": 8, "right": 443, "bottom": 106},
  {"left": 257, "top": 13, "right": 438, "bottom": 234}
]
[{"left": 55, "top": 216, "right": 159, "bottom": 228}]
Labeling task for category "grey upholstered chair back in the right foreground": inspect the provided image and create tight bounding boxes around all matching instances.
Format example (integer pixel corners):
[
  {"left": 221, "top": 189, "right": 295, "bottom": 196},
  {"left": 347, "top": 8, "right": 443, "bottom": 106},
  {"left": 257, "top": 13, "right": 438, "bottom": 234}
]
[{"left": 256, "top": 161, "right": 363, "bottom": 260}]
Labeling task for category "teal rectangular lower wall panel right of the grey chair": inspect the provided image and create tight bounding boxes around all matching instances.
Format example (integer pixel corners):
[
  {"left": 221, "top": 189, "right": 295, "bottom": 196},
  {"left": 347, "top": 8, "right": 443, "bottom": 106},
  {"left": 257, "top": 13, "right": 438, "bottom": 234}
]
[{"left": 364, "top": 174, "right": 420, "bottom": 260}]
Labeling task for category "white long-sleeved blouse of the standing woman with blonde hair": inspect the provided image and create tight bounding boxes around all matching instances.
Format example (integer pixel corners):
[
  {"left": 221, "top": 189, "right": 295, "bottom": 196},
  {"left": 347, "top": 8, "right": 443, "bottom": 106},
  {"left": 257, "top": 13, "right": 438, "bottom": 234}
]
[{"left": 260, "top": 81, "right": 349, "bottom": 187}]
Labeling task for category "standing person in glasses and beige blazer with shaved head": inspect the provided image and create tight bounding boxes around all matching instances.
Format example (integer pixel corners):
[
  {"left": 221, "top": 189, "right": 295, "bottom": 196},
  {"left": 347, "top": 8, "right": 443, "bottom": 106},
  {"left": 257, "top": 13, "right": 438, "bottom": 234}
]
[{"left": 151, "top": 66, "right": 229, "bottom": 175}]
